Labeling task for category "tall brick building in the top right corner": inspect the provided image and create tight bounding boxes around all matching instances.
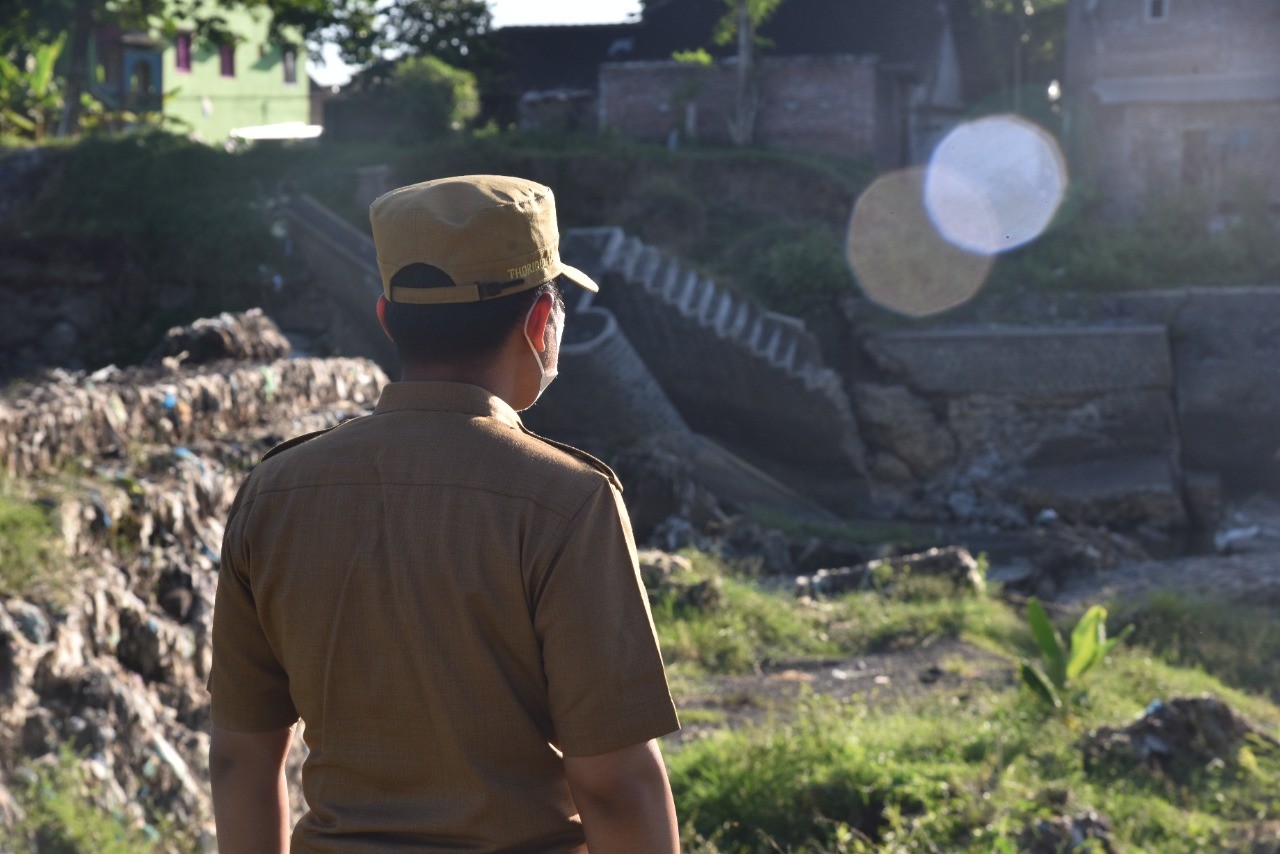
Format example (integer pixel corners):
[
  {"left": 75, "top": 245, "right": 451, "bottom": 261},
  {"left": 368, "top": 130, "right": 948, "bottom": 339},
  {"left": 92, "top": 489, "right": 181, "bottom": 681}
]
[{"left": 1066, "top": 0, "right": 1280, "bottom": 222}]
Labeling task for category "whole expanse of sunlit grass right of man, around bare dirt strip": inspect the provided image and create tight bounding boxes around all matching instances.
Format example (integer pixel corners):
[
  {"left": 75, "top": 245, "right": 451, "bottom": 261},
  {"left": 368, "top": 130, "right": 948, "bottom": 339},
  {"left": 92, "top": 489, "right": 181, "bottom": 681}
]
[{"left": 654, "top": 554, "right": 1280, "bottom": 854}]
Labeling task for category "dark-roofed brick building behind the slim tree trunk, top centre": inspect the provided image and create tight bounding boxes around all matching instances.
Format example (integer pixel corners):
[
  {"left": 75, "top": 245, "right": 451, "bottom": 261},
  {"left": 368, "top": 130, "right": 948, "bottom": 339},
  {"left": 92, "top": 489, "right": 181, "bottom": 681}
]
[{"left": 499, "top": 0, "right": 969, "bottom": 168}]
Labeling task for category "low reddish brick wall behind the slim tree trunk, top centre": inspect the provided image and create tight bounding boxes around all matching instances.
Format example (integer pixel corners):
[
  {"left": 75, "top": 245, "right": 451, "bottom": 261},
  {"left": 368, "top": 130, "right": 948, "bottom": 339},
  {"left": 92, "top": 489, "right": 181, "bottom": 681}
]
[{"left": 599, "top": 56, "right": 877, "bottom": 156}]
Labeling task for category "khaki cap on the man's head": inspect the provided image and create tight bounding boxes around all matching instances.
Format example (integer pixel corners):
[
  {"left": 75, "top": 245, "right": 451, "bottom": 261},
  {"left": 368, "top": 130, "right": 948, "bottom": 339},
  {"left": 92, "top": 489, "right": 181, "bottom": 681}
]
[{"left": 369, "top": 175, "right": 599, "bottom": 305}]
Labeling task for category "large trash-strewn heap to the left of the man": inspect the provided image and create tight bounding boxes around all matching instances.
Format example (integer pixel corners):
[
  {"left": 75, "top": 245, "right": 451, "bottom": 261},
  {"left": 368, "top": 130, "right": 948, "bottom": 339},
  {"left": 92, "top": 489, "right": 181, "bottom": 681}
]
[{"left": 0, "top": 315, "right": 387, "bottom": 845}]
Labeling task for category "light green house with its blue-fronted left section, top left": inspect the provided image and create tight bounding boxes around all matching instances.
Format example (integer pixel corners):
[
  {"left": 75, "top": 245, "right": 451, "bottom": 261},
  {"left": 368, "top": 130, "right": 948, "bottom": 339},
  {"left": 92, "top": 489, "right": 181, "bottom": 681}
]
[{"left": 91, "top": 9, "right": 314, "bottom": 143}]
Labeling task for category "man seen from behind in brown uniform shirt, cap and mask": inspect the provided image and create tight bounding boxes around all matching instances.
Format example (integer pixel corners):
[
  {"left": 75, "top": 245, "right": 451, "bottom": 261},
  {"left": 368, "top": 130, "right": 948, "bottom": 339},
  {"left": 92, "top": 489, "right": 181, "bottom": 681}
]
[{"left": 209, "top": 175, "right": 678, "bottom": 854}]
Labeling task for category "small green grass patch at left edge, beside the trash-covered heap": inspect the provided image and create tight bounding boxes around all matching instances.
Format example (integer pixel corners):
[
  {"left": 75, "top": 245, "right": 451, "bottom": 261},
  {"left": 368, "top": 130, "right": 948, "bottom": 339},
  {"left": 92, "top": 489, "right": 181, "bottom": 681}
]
[{"left": 0, "top": 484, "right": 65, "bottom": 597}]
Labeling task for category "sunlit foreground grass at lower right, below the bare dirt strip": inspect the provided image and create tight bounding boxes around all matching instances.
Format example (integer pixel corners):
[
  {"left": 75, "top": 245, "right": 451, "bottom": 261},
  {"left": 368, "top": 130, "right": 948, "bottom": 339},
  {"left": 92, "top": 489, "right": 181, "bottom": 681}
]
[{"left": 667, "top": 648, "right": 1280, "bottom": 854}]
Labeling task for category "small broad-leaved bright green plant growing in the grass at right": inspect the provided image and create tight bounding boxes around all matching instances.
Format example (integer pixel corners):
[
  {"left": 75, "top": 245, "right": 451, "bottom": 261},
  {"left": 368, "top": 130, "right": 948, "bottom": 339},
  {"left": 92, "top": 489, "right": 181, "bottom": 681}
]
[{"left": 1018, "top": 597, "right": 1133, "bottom": 709}]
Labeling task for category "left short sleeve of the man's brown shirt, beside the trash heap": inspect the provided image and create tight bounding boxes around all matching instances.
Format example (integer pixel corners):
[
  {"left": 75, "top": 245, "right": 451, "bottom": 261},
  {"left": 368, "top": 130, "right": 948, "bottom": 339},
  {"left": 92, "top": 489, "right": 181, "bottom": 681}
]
[{"left": 207, "top": 486, "right": 298, "bottom": 732}]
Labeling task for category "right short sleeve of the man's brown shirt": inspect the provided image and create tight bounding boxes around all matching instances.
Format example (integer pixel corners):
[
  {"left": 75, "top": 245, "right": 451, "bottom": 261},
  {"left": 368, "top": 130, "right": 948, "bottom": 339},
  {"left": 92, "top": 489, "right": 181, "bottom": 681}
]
[{"left": 534, "top": 479, "right": 680, "bottom": 757}]
